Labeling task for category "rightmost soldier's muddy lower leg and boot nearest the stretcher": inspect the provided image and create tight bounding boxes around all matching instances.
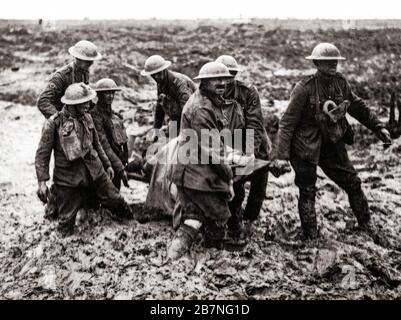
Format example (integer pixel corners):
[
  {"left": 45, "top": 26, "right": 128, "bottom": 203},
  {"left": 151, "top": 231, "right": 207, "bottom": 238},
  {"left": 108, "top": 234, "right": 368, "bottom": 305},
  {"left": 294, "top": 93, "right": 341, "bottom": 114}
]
[{"left": 298, "top": 191, "right": 319, "bottom": 240}]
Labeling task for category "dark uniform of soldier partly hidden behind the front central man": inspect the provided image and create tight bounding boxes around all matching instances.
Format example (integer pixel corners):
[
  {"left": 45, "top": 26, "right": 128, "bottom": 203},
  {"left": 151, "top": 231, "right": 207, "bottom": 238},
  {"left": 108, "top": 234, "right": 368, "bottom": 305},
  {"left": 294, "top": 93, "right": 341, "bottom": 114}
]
[{"left": 224, "top": 80, "right": 270, "bottom": 226}]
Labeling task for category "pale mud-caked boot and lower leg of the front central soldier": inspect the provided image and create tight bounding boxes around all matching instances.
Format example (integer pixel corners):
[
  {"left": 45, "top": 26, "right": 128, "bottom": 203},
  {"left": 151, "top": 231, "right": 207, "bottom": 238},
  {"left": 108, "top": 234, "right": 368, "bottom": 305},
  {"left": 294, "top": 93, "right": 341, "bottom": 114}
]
[{"left": 167, "top": 223, "right": 199, "bottom": 260}]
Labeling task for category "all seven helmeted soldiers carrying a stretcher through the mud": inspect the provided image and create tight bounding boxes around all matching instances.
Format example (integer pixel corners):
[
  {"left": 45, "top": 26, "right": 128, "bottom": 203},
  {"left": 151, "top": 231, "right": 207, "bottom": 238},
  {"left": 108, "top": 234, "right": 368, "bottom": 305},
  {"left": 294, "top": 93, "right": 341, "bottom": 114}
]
[{"left": 35, "top": 40, "right": 391, "bottom": 259}]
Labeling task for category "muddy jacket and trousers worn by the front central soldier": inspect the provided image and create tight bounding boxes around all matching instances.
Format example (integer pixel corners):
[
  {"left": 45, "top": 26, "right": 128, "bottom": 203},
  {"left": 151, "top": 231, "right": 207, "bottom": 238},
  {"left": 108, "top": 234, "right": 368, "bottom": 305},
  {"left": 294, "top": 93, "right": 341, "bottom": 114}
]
[{"left": 172, "top": 90, "right": 239, "bottom": 246}]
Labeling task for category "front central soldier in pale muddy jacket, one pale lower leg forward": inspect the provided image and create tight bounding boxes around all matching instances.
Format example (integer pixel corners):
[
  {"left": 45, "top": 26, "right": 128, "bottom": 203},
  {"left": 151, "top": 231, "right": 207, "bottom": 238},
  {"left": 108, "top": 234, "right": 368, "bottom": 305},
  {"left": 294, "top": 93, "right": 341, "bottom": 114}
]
[{"left": 168, "top": 62, "right": 238, "bottom": 259}]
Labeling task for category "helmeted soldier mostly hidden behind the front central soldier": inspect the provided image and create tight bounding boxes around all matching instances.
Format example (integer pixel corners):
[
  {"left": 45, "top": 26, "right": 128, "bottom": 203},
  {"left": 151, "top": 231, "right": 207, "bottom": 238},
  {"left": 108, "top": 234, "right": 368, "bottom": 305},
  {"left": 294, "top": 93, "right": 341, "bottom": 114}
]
[{"left": 216, "top": 55, "right": 271, "bottom": 239}]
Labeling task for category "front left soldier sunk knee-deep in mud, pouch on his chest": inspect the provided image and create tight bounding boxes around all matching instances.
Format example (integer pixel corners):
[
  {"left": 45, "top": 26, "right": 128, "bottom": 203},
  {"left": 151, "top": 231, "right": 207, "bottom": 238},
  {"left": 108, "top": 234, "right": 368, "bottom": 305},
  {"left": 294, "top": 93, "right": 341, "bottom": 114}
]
[{"left": 35, "top": 83, "right": 132, "bottom": 236}]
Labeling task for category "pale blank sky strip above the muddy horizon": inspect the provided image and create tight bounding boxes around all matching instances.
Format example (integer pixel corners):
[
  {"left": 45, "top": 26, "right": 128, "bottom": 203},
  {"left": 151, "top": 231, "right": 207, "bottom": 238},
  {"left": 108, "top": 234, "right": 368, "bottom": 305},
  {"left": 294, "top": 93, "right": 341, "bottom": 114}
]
[{"left": 0, "top": 0, "right": 401, "bottom": 19}]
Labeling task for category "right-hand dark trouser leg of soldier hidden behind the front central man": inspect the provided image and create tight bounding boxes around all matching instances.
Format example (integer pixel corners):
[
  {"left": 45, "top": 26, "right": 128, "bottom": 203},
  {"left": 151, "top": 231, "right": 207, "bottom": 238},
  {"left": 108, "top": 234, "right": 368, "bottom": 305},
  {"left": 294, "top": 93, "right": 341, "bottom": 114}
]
[{"left": 244, "top": 168, "right": 269, "bottom": 221}]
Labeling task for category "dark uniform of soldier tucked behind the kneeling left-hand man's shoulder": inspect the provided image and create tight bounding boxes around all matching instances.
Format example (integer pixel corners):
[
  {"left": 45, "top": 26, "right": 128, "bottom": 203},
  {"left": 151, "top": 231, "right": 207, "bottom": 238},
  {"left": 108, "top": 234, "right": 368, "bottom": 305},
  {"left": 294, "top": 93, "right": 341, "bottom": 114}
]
[{"left": 90, "top": 100, "right": 128, "bottom": 189}]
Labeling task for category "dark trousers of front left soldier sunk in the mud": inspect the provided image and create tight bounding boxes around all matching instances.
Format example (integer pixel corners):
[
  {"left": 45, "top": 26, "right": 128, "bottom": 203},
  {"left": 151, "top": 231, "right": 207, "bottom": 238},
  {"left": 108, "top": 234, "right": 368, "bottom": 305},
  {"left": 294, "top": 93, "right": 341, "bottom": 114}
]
[{"left": 55, "top": 172, "right": 132, "bottom": 231}]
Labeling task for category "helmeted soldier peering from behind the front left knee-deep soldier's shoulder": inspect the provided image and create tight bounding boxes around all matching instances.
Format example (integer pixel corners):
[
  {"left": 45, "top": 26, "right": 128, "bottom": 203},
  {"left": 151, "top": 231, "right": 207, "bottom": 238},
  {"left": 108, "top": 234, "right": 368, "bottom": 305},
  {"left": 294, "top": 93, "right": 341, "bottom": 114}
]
[{"left": 90, "top": 78, "right": 129, "bottom": 189}]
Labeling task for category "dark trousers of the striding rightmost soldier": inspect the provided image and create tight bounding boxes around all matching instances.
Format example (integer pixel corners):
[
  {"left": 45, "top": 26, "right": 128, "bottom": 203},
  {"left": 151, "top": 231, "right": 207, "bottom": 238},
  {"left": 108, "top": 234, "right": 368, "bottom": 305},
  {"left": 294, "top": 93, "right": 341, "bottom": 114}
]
[{"left": 291, "top": 143, "right": 370, "bottom": 238}]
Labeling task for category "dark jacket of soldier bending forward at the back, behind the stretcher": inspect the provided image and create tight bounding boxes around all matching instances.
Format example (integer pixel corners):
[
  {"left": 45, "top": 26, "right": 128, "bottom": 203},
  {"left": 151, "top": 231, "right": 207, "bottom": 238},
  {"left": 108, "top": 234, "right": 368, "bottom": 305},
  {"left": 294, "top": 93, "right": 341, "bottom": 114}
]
[{"left": 154, "top": 70, "right": 196, "bottom": 130}]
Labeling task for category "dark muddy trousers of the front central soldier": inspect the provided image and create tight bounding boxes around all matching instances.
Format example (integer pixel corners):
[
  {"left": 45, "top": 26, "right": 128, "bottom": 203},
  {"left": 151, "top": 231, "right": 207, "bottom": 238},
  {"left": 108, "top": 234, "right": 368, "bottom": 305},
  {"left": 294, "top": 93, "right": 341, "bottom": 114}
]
[{"left": 177, "top": 187, "right": 231, "bottom": 248}]
